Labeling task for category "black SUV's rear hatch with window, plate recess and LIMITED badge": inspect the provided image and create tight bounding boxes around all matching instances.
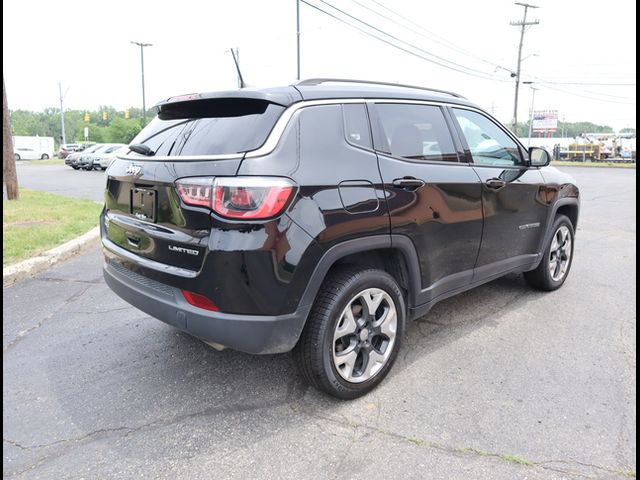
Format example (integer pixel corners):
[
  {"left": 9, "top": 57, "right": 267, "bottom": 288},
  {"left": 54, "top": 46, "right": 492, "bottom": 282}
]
[{"left": 102, "top": 98, "right": 285, "bottom": 277}]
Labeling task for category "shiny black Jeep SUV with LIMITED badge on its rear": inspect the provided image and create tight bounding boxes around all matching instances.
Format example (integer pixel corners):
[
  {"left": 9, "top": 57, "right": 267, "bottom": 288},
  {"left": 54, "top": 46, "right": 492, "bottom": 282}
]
[{"left": 101, "top": 79, "right": 579, "bottom": 398}]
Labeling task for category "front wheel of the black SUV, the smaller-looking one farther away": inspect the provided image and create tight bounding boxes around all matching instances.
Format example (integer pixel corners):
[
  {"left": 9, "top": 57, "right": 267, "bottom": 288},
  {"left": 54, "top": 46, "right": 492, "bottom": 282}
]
[{"left": 524, "top": 215, "right": 574, "bottom": 292}]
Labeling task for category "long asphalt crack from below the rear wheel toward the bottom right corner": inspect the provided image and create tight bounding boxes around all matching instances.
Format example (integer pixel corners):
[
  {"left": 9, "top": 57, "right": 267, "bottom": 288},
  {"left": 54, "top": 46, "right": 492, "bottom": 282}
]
[{"left": 290, "top": 405, "right": 625, "bottom": 478}]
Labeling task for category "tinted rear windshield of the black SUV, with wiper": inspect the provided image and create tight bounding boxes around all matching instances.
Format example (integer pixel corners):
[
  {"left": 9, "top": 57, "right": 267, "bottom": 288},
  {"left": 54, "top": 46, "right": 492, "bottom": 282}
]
[{"left": 131, "top": 99, "right": 284, "bottom": 160}]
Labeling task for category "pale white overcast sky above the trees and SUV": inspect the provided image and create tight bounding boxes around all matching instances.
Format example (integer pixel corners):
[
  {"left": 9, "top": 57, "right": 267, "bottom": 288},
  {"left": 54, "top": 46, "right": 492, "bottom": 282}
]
[{"left": 2, "top": 0, "right": 636, "bottom": 130}]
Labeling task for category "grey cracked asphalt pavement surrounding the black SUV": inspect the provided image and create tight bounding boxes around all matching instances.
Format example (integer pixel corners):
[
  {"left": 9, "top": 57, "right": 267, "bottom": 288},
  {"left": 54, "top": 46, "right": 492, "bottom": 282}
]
[{"left": 3, "top": 166, "right": 636, "bottom": 479}]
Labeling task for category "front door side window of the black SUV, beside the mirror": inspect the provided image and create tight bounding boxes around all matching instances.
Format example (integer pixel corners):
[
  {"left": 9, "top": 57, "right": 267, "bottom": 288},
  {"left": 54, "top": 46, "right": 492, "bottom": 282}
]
[{"left": 453, "top": 108, "right": 523, "bottom": 166}]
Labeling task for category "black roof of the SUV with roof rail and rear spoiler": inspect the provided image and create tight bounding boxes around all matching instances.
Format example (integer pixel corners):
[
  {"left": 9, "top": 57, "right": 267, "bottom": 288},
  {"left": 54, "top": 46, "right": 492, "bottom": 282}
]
[{"left": 156, "top": 79, "right": 475, "bottom": 111}]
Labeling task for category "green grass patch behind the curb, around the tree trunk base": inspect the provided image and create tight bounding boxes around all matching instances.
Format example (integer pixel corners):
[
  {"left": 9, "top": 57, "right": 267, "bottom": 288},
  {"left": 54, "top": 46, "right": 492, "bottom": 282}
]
[{"left": 2, "top": 189, "right": 102, "bottom": 266}]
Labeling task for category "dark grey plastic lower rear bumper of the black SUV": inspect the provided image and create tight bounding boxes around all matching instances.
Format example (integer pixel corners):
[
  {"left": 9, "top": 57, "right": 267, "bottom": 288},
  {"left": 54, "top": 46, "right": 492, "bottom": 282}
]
[{"left": 103, "top": 261, "right": 305, "bottom": 354}]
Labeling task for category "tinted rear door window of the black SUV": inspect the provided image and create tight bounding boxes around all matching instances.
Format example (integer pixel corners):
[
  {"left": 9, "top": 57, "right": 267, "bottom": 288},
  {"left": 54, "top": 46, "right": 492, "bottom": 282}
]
[{"left": 376, "top": 103, "right": 458, "bottom": 162}]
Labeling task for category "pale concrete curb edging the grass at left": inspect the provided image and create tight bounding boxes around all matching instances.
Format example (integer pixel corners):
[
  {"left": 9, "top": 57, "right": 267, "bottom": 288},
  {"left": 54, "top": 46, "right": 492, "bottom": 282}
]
[{"left": 2, "top": 227, "right": 100, "bottom": 287}]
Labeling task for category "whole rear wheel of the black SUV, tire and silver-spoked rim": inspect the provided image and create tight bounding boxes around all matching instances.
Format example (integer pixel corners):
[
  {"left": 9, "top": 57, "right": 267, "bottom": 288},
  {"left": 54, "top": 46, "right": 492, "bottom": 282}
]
[{"left": 293, "top": 267, "right": 405, "bottom": 399}]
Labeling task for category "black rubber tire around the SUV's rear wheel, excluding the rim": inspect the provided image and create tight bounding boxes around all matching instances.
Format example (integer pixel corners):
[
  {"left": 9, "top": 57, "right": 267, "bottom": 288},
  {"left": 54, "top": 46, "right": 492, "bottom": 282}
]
[{"left": 293, "top": 266, "right": 405, "bottom": 399}]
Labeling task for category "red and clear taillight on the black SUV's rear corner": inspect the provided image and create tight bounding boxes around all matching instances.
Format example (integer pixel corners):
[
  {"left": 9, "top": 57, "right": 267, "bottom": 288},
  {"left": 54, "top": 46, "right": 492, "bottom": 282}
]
[{"left": 176, "top": 177, "right": 296, "bottom": 220}]
